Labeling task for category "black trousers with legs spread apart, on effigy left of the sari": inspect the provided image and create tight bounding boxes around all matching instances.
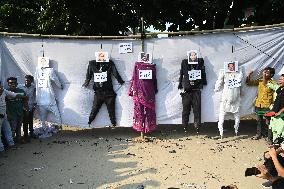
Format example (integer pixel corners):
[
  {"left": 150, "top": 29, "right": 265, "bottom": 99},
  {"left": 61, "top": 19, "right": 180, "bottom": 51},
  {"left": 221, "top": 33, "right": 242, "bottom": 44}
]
[{"left": 88, "top": 91, "right": 116, "bottom": 125}]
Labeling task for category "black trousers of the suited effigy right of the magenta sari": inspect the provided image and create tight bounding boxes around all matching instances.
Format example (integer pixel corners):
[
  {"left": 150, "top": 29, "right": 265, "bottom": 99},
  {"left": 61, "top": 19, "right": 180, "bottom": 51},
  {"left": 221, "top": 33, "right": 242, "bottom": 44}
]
[{"left": 181, "top": 90, "right": 201, "bottom": 128}]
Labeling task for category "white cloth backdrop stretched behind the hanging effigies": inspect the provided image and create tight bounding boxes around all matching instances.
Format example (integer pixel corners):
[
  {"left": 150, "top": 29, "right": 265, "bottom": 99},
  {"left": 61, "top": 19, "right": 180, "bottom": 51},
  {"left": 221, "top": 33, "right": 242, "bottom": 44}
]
[{"left": 0, "top": 28, "right": 284, "bottom": 127}]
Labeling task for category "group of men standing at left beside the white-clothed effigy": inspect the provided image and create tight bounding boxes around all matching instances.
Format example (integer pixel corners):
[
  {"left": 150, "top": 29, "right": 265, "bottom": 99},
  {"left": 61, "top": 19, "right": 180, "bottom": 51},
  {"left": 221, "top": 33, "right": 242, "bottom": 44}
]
[{"left": 0, "top": 75, "right": 36, "bottom": 155}]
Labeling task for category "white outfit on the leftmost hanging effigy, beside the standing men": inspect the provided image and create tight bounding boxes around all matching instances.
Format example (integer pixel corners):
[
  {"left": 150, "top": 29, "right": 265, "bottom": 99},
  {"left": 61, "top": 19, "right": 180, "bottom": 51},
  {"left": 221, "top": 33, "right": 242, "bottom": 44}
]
[{"left": 35, "top": 67, "right": 62, "bottom": 126}]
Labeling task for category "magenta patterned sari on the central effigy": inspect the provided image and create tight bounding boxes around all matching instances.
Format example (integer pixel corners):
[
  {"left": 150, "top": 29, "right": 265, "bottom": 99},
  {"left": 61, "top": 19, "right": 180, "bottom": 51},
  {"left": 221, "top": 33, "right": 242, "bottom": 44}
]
[{"left": 128, "top": 62, "right": 158, "bottom": 133}]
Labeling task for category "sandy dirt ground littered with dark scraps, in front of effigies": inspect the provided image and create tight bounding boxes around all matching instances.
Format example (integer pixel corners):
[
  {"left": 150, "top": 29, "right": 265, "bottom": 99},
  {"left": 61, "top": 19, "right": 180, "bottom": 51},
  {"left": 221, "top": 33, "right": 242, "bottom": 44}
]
[{"left": 0, "top": 121, "right": 267, "bottom": 189}]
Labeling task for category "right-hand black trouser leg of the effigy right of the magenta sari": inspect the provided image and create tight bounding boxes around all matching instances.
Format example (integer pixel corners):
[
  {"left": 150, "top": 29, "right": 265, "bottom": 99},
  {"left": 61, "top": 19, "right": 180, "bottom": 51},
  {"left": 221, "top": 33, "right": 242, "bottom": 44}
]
[{"left": 191, "top": 90, "right": 201, "bottom": 129}]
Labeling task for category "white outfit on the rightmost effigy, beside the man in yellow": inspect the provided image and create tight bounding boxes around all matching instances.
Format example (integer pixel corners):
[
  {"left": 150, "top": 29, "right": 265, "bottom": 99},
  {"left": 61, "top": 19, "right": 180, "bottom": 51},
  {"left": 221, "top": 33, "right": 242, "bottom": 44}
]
[{"left": 214, "top": 69, "right": 243, "bottom": 138}]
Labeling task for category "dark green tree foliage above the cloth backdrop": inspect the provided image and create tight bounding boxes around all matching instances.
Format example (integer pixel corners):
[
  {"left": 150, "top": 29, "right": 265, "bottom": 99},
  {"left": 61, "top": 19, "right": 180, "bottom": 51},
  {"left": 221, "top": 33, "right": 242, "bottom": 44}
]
[{"left": 0, "top": 0, "right": 284, "bottom": 35}]
